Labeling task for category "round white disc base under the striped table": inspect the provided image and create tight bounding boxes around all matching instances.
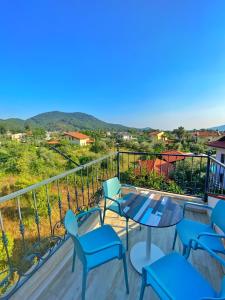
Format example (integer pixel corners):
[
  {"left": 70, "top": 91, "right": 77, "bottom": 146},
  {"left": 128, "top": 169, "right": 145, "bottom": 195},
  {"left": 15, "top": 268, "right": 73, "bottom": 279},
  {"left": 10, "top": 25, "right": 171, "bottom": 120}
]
[{"left": 130, "top": 242, "right": 164, "bottom": 274}]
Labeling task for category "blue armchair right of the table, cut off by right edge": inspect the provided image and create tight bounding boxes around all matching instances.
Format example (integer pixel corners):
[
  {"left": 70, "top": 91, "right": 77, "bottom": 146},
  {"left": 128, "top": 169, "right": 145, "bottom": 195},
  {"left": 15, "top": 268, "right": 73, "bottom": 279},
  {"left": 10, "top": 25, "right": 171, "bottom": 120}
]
[{"left": 173, "top": 200, "right": 225, "bottom": 254}]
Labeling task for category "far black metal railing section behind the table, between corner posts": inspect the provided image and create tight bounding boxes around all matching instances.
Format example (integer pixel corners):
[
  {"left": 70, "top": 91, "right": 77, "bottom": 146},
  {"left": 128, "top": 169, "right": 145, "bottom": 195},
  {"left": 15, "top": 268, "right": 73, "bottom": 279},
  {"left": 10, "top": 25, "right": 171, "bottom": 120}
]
[{"left": 119, "top": 151, "right": 208, "bottom": 197}]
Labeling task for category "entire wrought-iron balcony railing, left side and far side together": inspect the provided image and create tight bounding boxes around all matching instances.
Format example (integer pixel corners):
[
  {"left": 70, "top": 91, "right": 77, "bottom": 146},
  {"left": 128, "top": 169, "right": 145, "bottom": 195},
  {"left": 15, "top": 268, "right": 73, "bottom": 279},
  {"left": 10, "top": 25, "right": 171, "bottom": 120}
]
[{"left": 0, "top": 151, "right": 225, "bottom": 299}]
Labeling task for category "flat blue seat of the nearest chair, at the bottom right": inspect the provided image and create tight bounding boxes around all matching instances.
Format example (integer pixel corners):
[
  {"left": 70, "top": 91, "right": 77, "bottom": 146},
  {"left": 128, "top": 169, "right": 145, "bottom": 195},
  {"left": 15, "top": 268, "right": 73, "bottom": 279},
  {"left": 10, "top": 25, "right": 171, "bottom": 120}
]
[{"left": 145, "top": 252, "right": 215, "bottom": 300}]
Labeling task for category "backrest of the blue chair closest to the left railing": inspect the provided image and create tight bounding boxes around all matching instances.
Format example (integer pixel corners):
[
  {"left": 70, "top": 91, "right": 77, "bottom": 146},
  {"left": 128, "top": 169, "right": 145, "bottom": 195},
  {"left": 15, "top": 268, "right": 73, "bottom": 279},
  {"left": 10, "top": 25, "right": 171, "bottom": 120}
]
[{"left": 64, "top": 209, "right": 86, "bottom": 263}]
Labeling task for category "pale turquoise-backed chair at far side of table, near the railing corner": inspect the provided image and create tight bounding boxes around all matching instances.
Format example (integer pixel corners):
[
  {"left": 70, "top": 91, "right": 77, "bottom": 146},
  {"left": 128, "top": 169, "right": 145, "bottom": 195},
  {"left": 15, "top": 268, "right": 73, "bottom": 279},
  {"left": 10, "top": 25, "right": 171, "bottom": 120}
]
[{"left": 103, "top": 177, "right": 137, "bottom": 250}]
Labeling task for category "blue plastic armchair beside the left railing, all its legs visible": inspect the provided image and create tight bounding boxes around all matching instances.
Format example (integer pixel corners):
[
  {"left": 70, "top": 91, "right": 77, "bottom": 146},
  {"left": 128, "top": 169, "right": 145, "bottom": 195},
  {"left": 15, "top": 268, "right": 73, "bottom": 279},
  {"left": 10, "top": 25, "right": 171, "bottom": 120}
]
[{"left": 64, "top": 208, "right": 129, "bottom": 300}]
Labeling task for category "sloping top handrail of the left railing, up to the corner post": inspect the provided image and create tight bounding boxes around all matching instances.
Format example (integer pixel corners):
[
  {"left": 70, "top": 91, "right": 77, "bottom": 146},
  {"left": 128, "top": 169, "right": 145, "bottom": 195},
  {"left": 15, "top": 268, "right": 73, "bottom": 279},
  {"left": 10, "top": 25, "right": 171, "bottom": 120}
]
[{"left": 0, "top": 152, "right": 117, "bottom": 203}]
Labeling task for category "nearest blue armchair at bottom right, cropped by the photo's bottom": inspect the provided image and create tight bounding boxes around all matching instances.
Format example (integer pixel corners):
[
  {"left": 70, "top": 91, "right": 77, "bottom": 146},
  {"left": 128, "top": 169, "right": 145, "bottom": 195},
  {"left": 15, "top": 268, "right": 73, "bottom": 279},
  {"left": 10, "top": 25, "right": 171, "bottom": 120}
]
[{"left": 140, "top": 240, "right": 225, "bottom": 300}]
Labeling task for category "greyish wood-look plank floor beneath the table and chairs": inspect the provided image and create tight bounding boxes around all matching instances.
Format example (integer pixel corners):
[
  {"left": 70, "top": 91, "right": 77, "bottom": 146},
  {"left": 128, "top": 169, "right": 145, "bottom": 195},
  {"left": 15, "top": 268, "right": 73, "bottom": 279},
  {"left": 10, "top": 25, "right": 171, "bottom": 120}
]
[{"left": 38, "top": 192, "right": 223, "bottom": 300}]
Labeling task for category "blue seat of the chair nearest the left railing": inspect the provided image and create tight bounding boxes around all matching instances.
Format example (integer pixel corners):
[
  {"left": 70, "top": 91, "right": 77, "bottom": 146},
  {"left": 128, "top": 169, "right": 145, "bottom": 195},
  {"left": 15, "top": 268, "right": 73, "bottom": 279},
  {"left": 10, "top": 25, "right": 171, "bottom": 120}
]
[{"left": 80, "top": 225, "right": 125, "bottom": 270}]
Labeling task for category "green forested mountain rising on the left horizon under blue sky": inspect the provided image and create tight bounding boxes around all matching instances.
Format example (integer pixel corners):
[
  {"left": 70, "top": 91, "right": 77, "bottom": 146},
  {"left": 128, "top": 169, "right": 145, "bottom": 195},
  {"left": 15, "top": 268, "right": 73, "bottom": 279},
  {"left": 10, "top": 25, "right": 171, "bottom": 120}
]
[{"left": 0, "top": 111, "right": 132, "bottom": 131}]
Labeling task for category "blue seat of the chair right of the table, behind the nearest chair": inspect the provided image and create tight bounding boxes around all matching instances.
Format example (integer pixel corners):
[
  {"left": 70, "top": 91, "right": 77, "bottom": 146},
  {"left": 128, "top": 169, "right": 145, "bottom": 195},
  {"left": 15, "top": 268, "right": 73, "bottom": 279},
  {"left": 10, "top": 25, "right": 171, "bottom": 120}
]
[{"left": 176, "top": 219, "right": 225, "bottom": 253}]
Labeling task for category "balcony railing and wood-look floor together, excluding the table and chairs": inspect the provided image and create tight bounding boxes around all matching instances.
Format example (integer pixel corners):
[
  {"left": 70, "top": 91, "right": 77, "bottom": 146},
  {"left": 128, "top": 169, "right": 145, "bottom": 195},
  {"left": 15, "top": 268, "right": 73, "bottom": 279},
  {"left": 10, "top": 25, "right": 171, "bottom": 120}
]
[{"left": 0, "top": 152, "right": 225, "bottom": 299}]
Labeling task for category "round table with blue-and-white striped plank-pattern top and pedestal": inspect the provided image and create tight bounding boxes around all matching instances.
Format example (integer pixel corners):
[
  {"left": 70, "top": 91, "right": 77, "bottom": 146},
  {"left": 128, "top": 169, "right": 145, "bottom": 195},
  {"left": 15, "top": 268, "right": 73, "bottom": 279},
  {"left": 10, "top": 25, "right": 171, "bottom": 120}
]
[{"left": 121, "top": 193, "right": 183, "bottom": 273}]
